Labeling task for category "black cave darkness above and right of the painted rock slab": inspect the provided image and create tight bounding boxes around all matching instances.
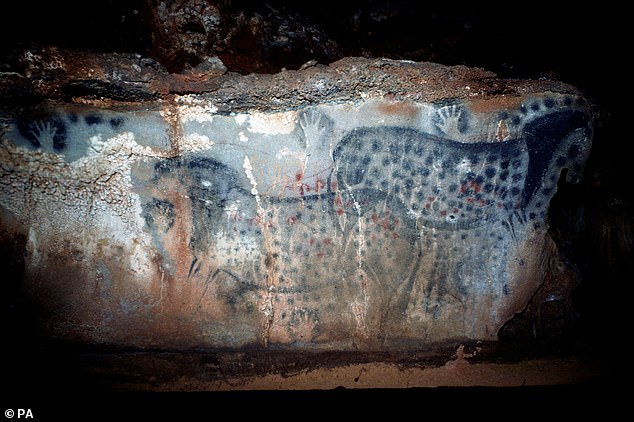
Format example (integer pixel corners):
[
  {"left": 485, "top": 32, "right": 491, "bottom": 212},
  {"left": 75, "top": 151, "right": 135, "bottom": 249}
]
[{"left": 0, "top": 0, "right": 634, "bottom": 408}]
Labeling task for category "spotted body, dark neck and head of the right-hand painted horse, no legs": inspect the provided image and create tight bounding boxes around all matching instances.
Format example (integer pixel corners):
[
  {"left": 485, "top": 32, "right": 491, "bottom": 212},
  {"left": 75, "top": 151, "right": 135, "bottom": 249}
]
[{"left": 333, "top": 108, "right": 588, "bottom": 230}]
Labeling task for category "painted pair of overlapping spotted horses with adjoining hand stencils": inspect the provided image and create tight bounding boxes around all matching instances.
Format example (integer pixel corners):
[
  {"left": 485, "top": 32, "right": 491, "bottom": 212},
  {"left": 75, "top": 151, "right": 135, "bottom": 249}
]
[{"left": 137, "top": 97, "right": 591, "bottom": 343}]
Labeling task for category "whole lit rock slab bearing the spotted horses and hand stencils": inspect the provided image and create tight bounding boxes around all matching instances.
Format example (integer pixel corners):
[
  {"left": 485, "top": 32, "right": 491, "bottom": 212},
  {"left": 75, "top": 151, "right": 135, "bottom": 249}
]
[{"left": 0, "top": 49, "right": 592, "bottom": 350}]
